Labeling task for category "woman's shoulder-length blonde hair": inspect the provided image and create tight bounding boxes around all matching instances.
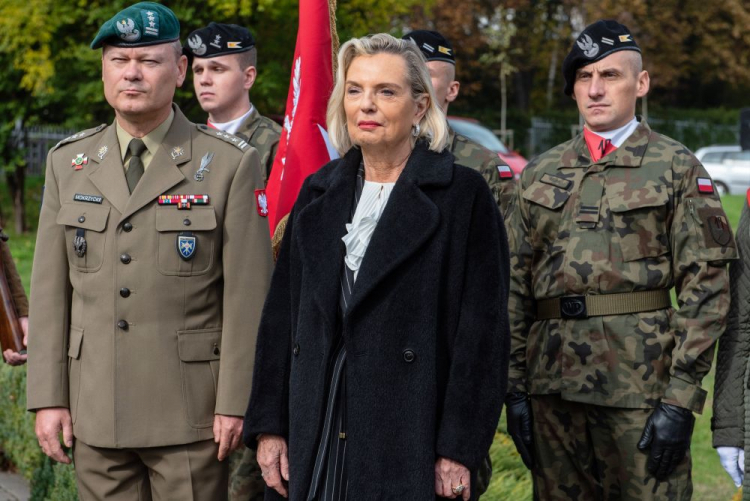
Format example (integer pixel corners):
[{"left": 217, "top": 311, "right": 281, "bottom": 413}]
[{"left": 326, "top": 33, "right": 448, "bottom": 155}]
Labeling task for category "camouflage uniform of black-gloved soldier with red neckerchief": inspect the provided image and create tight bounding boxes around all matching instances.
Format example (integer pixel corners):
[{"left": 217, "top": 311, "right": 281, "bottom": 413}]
[{"left": 506, "top": 122, "right": 736, "bottom": 500}]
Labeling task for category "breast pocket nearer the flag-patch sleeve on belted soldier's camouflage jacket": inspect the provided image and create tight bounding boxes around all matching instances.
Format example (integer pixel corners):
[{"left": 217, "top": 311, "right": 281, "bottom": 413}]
[{"left": 606, "top": 183, "right": 669, "bottom": 262}]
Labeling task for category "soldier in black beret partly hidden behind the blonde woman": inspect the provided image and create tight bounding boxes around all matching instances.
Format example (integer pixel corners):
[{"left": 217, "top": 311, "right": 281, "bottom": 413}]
[{"left": 403, "top": 30, "right": 515, "bottom": 216}]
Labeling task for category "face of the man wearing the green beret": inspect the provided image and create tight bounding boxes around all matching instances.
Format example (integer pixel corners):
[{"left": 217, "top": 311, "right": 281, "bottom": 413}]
[{"left": 102, "top": 43, "right": 187, "bottom": 122}]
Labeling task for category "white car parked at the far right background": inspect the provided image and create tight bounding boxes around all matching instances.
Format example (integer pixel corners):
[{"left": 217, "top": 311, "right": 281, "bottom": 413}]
[{"left": 695, "top": 146, "right": 750, "bottom": 195}]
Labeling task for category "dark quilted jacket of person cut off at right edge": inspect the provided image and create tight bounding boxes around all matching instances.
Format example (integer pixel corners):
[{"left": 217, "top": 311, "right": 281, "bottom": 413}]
[{"left": 711, "top": 197, "right": 750, "bottom": 494}]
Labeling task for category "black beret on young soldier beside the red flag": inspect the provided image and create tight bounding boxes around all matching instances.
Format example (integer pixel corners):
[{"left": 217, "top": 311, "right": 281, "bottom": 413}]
[{"left": 182, "top": 23, "right": 255, "bottom": 58}]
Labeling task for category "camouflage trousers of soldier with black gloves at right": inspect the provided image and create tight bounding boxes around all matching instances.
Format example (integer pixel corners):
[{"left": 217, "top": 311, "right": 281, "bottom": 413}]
[{"left": 531, "top": 395, "right": 693, "bottom": 501}]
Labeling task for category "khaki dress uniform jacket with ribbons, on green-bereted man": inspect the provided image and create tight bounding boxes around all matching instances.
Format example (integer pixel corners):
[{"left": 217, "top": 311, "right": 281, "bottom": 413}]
[{"left": 27, "top": 107, "right": 272, "bottom": 447}]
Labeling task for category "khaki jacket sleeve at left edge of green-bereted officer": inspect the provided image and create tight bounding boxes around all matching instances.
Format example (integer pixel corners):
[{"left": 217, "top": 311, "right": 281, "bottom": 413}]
[{"left": 26, "top": 150, "right": 72, "bottom": 410}]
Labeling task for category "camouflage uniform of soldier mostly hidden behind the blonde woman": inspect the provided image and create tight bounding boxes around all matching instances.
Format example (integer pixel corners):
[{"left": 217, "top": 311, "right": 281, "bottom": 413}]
[{"left": 448, "top": 127, "right": 516, "bottom": 217}]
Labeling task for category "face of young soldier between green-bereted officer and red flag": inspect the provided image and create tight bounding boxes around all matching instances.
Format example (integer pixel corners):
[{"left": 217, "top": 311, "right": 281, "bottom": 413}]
[{"left": 193, "top": 54, "right": 255, "bottom": 122}]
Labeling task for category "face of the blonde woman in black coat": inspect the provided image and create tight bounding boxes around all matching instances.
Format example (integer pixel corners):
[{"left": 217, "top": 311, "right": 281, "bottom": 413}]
[{"left": 344, "top": 54, "right": 427, "bottom": 153}]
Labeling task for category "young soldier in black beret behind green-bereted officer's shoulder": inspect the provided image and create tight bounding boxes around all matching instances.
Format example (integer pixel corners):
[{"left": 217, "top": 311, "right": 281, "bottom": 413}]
[{"left": 184, "top": 23, "right": 281, "bottom": 181}]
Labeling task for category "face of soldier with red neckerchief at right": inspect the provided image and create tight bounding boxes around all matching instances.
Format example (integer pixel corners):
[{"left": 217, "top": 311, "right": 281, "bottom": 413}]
[{"left": 573, "top": 51, "right": 649, "bottom": 132}]
